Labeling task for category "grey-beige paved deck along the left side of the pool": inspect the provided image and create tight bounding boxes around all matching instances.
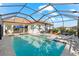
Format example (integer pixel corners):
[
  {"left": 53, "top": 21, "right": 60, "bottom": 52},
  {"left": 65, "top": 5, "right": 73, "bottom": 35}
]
[{"left": 0, "top": 36, "right": 15, "bottom": 56}]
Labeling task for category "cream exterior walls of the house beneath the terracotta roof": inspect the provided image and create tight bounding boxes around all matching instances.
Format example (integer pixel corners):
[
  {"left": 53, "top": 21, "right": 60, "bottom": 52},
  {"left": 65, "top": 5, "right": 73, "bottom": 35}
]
[{"left": 3, "top": 22, "right": 50, "bottom": 35}]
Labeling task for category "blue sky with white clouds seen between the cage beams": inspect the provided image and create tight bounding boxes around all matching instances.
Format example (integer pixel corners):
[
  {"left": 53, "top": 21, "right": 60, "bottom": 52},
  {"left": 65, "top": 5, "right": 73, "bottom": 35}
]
[{"left": 0, "top": 3, "right": 79, "bottom": 27}]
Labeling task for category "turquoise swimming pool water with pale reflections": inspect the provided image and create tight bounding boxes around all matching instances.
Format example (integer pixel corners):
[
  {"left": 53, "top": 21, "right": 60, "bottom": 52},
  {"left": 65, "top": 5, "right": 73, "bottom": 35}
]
[{"left": 13, "top": 35, "right": 65, "bottom": 56}]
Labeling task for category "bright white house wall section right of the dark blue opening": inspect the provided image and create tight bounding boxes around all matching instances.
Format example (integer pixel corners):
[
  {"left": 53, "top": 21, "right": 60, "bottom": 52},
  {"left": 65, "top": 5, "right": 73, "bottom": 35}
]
[{"left": 28, "top": 24, "right": 51, "bottom": 33}]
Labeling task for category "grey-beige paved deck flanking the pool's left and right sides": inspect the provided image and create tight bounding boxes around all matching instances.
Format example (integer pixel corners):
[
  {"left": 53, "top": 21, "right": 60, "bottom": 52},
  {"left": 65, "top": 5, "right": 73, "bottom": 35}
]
[{"left": 0, "top": 36, "right": 78, "bottom": 56}]
